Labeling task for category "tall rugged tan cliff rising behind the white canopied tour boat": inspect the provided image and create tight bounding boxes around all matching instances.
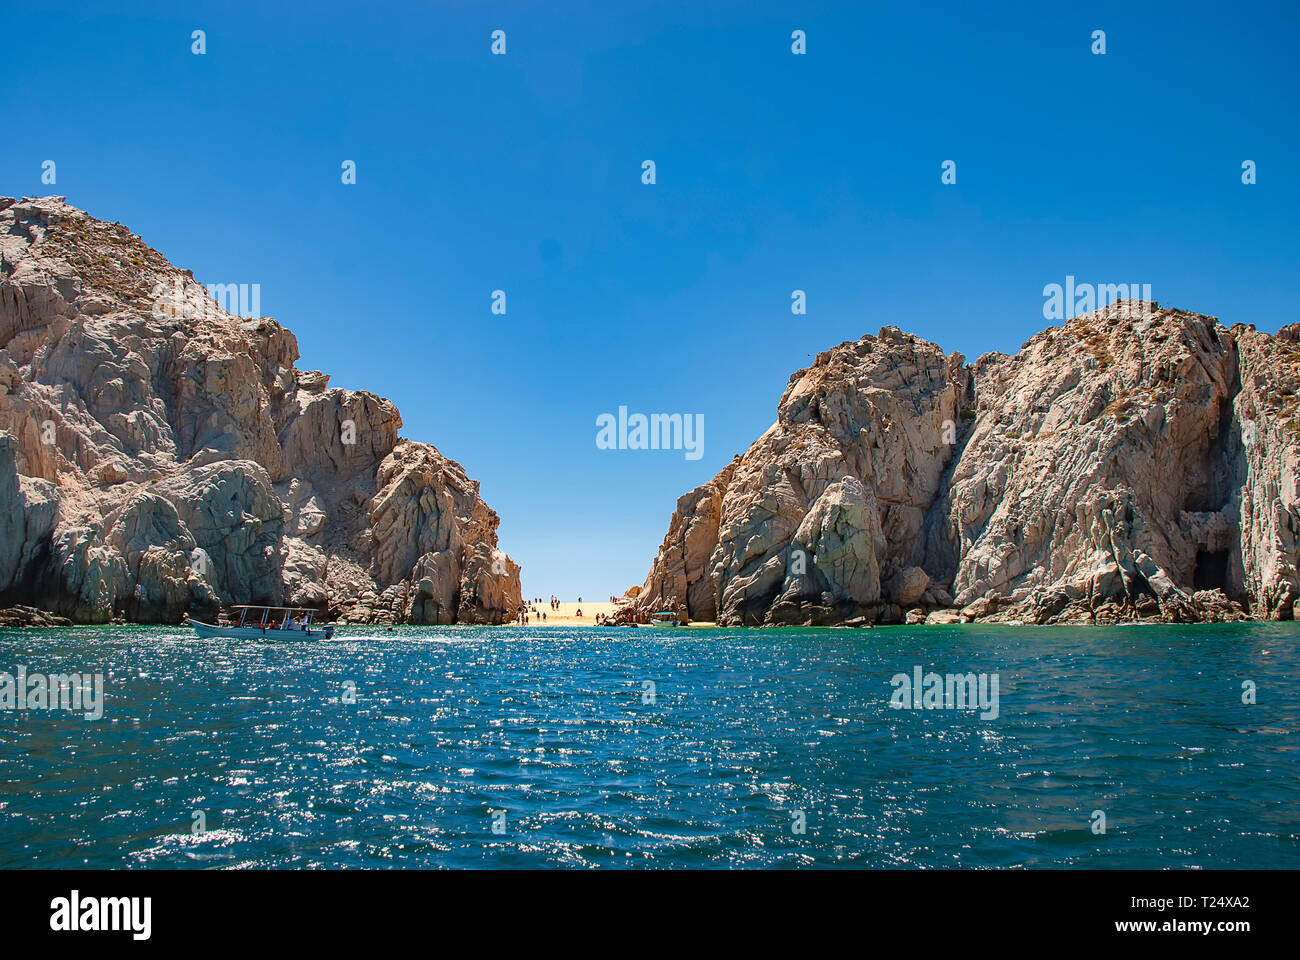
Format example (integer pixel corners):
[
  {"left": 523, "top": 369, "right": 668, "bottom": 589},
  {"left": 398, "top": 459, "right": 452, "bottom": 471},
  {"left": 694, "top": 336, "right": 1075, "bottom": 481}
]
[{"left": 0, "top": 198, "right": 520, "bottom": 623}]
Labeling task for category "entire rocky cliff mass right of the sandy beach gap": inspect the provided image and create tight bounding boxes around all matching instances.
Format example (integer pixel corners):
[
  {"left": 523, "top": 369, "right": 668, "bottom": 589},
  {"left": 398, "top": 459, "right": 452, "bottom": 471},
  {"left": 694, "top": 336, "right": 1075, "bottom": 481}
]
[{"left": 636, "top": 300, "right": 1300, "bottom": 624}]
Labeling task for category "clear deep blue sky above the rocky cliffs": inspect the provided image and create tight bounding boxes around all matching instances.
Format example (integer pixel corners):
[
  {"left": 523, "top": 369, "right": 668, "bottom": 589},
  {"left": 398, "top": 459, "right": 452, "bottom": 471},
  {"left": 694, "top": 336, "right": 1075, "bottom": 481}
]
[{"left": 0, "top": 0, "right": 1300, "bottom": 598}]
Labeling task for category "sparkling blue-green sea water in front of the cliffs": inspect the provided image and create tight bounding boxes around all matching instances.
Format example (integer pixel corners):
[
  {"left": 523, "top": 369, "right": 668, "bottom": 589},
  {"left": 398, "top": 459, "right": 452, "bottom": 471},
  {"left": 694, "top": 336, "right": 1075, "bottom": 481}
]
[{"left": 0, "top": 623, "right": 1300, "bottom": 868}]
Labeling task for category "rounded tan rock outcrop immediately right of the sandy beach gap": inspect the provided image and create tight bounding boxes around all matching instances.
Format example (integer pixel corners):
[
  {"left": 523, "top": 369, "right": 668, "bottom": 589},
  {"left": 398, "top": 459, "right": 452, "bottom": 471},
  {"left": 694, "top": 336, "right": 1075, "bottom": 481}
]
[{"left": 636, "top": 327, "right": 970, "bottom": 624}]
